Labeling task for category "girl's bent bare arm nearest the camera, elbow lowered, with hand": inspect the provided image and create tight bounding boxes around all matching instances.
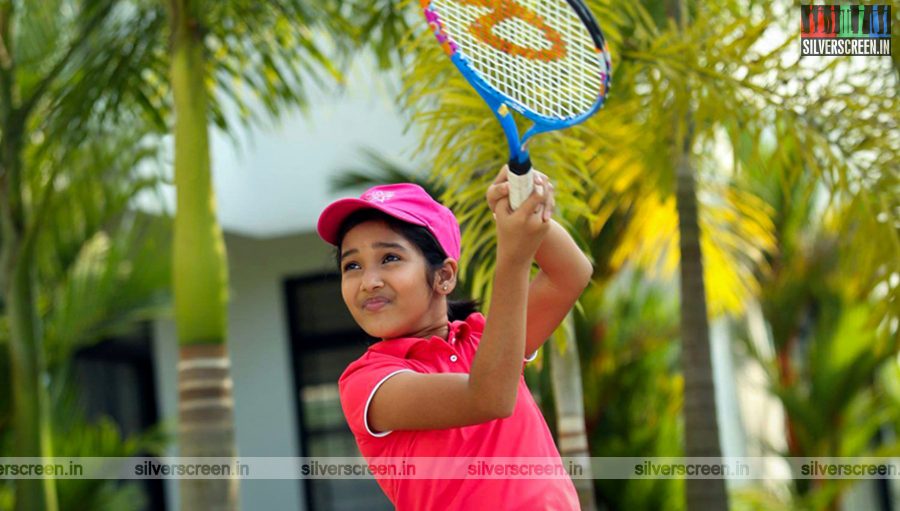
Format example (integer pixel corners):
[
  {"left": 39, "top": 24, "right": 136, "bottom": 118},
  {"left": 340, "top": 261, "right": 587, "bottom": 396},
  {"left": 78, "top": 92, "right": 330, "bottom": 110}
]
[{"left": 366, "top": 188, "right": 551, "bottom": 432}]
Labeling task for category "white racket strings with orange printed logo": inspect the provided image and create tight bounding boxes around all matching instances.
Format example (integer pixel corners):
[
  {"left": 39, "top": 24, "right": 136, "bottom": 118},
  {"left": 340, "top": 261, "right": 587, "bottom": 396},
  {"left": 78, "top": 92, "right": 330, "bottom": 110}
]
[{"left": 431, "top": 0, "right": 608, "bottom": 119}]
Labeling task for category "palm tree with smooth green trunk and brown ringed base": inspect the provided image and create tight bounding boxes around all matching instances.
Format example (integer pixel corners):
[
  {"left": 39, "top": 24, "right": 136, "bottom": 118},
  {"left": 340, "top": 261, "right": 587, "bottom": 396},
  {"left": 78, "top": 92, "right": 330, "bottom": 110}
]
[{"left": 168, "top": 0, "right": 412, "bottom": 509}]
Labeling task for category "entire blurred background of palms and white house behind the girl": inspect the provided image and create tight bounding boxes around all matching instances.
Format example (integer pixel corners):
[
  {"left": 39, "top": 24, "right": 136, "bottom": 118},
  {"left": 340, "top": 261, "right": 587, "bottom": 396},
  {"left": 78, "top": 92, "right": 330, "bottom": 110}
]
[{"left": 0, "top": 0, "right": 900, "bottom": 511}]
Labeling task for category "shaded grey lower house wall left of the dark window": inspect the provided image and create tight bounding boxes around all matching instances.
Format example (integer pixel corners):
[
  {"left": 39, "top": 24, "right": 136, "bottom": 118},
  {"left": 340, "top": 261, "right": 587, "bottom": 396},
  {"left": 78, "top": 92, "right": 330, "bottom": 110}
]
[{"left": 154, "top": 233, "right": 333, "bottom": 510}]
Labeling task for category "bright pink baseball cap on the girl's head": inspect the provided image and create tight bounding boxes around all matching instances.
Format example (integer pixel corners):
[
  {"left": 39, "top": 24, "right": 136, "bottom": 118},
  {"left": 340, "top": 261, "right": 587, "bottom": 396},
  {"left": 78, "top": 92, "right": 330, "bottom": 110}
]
[{"left": 317, "top": 183, "right": 460, "bottom": 260}]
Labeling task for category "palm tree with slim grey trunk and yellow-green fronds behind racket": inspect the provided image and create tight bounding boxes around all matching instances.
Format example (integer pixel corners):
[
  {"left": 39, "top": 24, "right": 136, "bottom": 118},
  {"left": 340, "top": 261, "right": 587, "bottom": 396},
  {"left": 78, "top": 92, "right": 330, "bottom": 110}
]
[{"left": 405, "top": 1, "right": 880, "bottom": 508}]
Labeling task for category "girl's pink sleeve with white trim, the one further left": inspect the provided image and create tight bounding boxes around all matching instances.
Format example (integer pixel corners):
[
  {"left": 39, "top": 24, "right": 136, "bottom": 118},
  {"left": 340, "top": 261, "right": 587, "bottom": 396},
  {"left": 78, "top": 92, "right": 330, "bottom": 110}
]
[{"left": 338, "top": 354, "right": 415, "bottom": 437}]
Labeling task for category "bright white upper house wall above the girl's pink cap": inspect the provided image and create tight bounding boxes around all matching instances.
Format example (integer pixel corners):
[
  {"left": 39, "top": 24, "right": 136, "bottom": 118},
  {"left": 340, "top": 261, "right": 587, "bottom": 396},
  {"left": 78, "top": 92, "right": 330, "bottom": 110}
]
[{"left": 136, "top": 56, "right": 426, "bottom": 240}]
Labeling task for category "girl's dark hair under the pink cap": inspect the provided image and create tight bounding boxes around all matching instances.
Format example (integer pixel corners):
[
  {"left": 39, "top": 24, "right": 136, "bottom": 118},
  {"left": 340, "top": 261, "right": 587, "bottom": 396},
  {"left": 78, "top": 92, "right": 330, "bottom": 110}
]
[{"left": 335, "top": 209, "right": 479, "bottom": 321}]
